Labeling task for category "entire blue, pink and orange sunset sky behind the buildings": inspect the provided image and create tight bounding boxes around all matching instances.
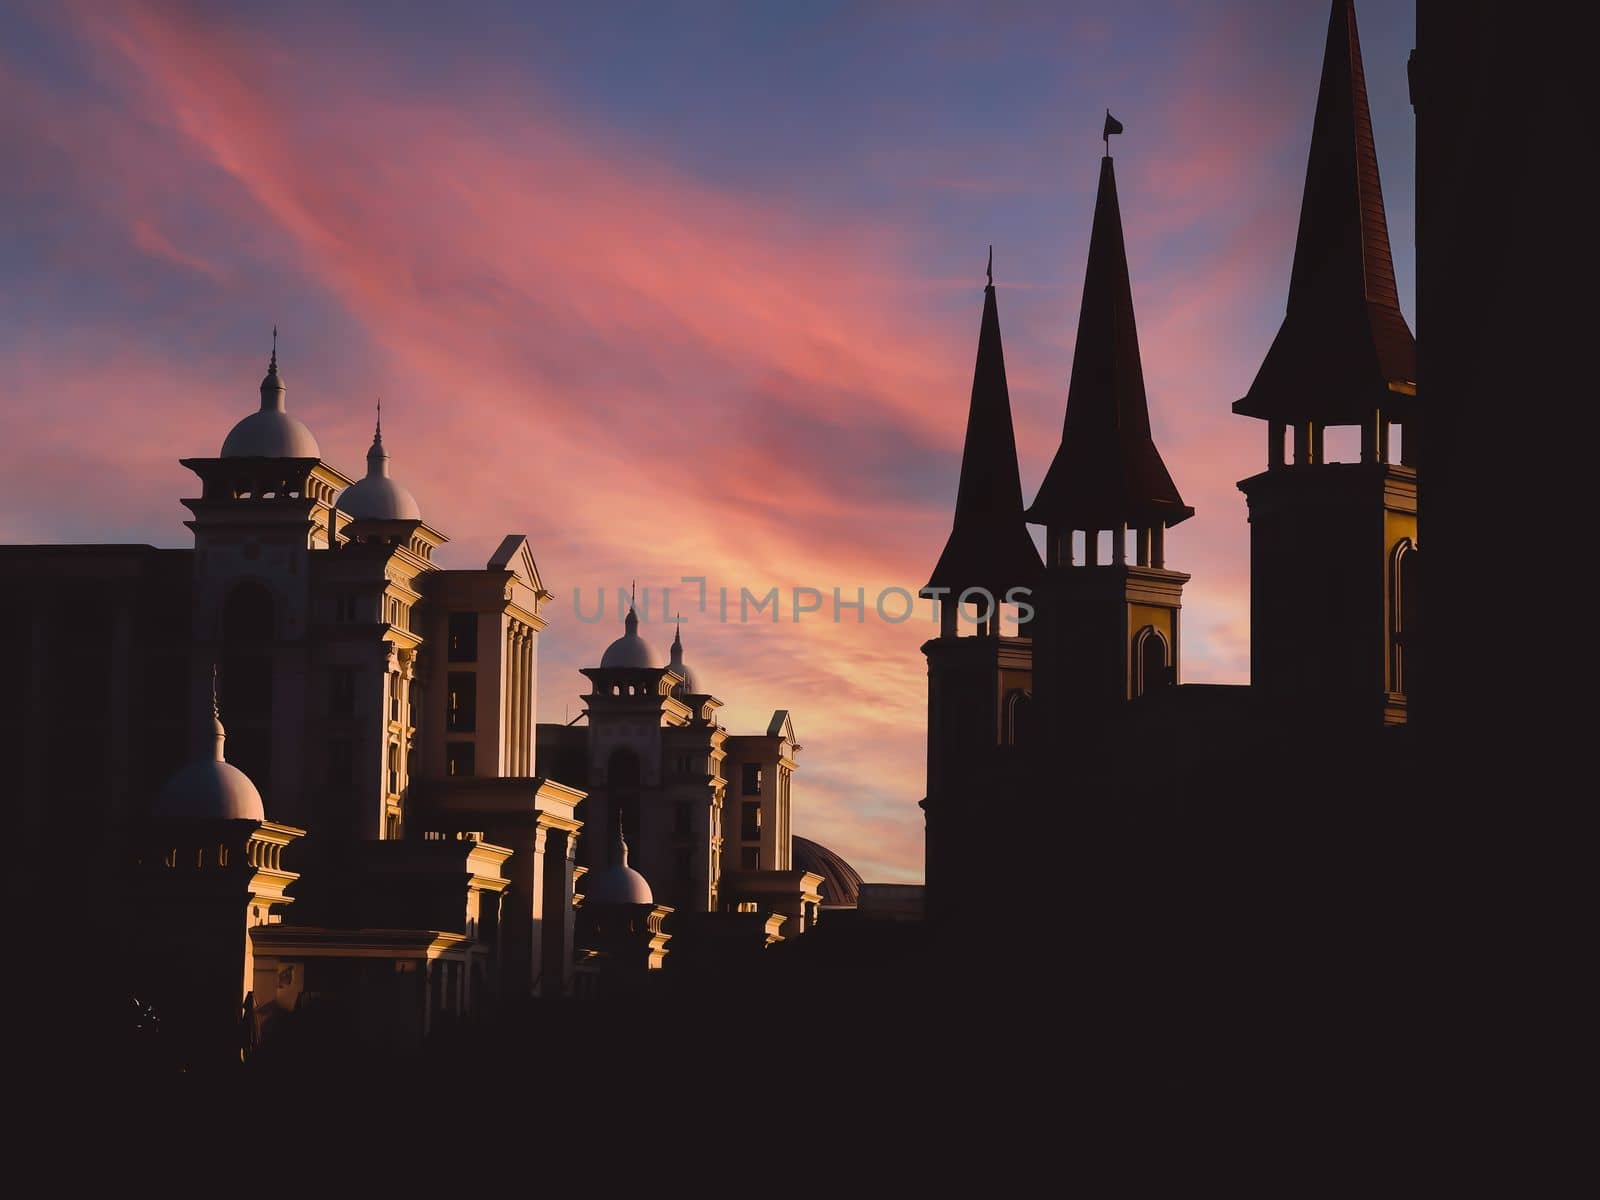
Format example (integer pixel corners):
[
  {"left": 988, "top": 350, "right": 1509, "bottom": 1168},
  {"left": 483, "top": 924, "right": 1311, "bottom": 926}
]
[{"left": 0, "top": 0, "right": 1414, "bottom": 882}]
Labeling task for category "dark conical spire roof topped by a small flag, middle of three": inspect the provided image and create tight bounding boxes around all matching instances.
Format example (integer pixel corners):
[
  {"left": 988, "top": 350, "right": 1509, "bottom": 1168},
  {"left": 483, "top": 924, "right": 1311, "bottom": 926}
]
[{"left": 1027, "top": 157, "right": 1194, "bottom": 530}]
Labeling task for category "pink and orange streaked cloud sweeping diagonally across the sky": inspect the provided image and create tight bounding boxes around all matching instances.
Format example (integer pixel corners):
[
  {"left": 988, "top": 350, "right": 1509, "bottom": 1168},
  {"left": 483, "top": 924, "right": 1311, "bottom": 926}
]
[{"left": 0, "top": 3, "right": 1376, "bottom": 880}]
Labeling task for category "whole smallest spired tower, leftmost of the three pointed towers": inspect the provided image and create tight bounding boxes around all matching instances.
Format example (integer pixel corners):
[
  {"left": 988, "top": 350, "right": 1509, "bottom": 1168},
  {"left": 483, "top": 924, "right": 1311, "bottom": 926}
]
[{"left": 922, "top": 253, "right": 1040, "bottom": 918}]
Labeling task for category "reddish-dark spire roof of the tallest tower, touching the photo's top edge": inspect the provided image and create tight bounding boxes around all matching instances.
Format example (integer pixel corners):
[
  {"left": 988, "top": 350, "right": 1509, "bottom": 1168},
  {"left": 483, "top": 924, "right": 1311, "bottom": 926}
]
[{"left": 1234, "top": 0, "right": 1416, "bottom": 424}]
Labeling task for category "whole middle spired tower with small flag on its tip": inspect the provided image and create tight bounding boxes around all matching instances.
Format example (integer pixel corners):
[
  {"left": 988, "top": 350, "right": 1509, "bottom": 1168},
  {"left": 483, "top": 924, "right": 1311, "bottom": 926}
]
[{"left": 1027, "top": 144, "right": 1194, "bottom": 742}]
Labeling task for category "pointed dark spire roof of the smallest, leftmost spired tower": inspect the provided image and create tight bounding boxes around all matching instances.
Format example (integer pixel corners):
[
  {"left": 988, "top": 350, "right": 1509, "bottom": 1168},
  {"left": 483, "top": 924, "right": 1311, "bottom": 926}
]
[{"left": 923, "top": 246, "right": 1040, "bottom": 600}]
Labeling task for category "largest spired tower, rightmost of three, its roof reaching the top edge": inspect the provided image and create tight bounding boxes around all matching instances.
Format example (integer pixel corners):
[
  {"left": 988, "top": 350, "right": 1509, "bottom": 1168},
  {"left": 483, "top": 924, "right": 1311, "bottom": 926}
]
[{"left": 1234, "top": 0, "right": 1418, "bottom": 726}]
